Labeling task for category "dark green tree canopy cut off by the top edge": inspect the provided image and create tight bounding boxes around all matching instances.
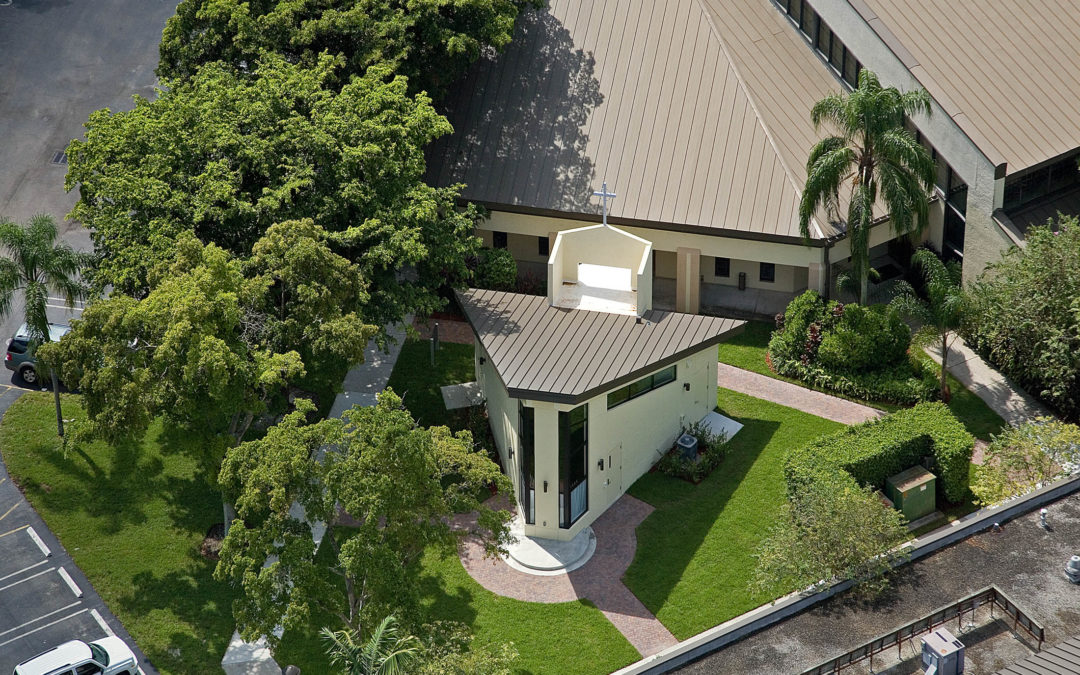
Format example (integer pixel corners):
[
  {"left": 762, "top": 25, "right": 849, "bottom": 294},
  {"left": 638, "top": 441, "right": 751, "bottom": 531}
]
[{"left": 158, "top": 0, "right": 537, "bottom": 97}]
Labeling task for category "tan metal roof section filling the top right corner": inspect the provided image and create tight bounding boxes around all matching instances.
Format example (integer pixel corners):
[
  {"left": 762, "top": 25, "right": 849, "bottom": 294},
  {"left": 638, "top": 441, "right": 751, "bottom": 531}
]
[{"left": 849, "top": 0, "right": 1080, "bottom": 173}]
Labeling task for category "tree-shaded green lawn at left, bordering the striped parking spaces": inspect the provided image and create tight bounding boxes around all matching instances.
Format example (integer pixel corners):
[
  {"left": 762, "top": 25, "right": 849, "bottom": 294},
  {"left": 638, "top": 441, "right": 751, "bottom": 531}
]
[{"left": 0, "top": 393, "right": 233, "bottom": 675}]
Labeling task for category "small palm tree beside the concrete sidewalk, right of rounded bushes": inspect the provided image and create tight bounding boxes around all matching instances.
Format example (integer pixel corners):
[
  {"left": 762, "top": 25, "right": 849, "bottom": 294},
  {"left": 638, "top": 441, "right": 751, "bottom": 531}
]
[{"left": 891, "top": 248, "right": 968, "bottom": 402}]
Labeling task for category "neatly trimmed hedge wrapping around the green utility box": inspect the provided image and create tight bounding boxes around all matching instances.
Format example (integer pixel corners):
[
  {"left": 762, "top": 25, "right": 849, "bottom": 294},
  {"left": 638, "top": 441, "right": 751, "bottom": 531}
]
[{"left": 784, "top": 403, "right": 975, "bottom": 503}]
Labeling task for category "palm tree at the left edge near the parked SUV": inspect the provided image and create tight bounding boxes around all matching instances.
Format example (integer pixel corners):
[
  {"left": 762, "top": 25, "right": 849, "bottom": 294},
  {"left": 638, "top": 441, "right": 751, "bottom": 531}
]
[{"left": 0, "top": 214, "right": 90, "bottom": 436}]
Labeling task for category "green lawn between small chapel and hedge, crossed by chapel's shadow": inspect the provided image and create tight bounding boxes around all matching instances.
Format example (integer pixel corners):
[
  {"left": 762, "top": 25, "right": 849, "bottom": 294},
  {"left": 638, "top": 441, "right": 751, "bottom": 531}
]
[{"left": 624, "top": 389, "right": 842, "bottom": 639}]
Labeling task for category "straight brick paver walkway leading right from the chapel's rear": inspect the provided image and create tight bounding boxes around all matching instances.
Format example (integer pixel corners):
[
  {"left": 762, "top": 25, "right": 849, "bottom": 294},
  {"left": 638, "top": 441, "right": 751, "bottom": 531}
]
[{"left": 716, "top": 363, "right": 885, "bottom": 424}]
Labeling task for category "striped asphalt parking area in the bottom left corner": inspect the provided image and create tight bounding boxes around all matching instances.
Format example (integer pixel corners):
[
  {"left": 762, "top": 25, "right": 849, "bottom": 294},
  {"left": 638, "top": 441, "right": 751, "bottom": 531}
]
[{"left": 0, "top": 384, "right": 157, "bottom": 675}]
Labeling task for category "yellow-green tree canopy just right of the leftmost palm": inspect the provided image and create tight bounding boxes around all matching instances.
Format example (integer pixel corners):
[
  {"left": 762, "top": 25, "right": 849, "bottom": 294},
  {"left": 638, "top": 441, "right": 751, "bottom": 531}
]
[{"left": 40, "top": 233, "right": 305, "bottom": 443}]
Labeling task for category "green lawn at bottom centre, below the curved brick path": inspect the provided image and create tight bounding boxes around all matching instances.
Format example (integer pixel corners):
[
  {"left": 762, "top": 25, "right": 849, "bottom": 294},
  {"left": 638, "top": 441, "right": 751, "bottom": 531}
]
[{"left": 274, "top": 549, "right": 640, "bottom": 675}]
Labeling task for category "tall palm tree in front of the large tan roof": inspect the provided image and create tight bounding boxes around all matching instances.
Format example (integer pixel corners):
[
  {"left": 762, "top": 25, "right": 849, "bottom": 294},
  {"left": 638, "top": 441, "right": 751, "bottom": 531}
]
[{"left": 799, "top": 68, "right": 934, "bottom": 302}]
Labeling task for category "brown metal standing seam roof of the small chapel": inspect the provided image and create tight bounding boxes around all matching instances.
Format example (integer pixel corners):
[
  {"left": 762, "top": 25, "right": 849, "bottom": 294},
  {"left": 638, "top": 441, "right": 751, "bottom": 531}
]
[{"left": 458, "top": 288, "right": 744, "bottom": 404}]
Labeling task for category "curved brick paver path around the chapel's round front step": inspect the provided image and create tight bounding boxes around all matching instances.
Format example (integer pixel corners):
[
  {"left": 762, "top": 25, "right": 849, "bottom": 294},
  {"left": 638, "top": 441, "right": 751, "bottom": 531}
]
[{"left": 460, "top": 495, "right": 678, "bottom": 657}]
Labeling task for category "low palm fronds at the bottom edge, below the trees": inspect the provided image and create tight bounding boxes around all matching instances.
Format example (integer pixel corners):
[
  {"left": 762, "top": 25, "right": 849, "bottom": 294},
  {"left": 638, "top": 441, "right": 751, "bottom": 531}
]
[{"left": 322, "top": 617, "right": 420, "bottom": 675}]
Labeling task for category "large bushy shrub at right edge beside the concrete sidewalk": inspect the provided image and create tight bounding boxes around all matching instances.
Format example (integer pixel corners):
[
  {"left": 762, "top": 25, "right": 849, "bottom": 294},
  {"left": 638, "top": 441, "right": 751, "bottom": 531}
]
[{"left": 961, "top": 217, "right": 1080, "bottom": 421}]
